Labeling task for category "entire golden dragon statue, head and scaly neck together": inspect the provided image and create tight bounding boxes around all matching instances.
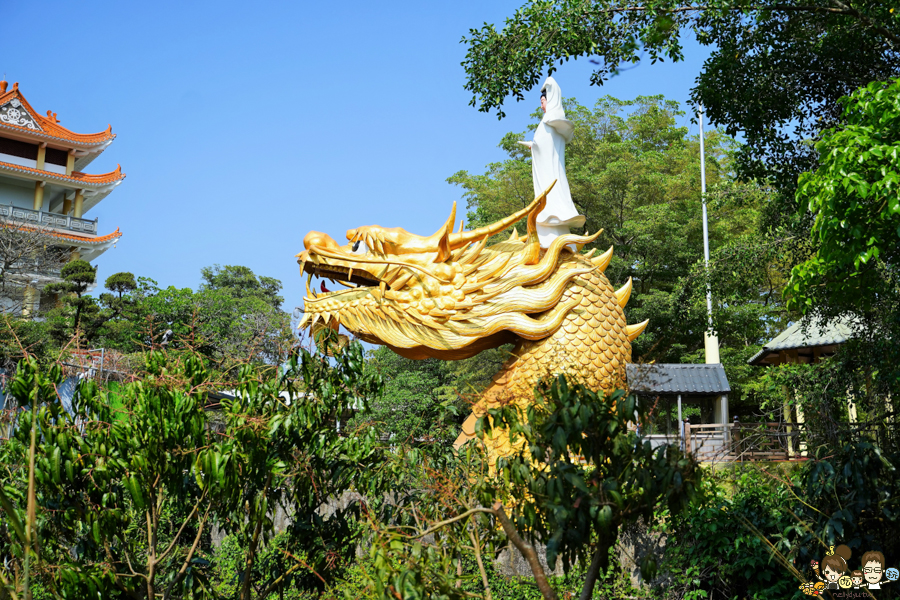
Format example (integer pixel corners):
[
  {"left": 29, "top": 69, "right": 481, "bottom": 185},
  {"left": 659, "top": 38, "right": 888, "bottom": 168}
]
[{"left": 297, "top": 185, "right": 647, "bottom": 452}]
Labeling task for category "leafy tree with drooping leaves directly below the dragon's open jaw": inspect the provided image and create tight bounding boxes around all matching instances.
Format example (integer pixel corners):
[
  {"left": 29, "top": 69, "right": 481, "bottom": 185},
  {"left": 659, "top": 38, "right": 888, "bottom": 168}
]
[{"left": 215, "top": 343, "right": 388, "bottom": 600}]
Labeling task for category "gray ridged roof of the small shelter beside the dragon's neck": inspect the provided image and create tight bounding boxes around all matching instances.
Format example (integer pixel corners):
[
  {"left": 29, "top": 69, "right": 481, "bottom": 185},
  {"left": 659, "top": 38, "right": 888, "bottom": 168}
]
[{"left": 626, "top": 363, "right": 731, "bottom": 394}]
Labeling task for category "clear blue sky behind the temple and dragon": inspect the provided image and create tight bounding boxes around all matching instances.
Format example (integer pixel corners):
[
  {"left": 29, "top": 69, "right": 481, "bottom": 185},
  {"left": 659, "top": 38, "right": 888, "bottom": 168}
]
[{"left": 0, "top": 0, "right": 707, "bottom": 310}]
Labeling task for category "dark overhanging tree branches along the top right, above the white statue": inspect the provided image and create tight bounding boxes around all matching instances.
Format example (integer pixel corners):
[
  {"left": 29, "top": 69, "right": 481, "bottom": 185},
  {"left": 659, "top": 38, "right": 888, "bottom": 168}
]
[{"left": 463, "top": 0, "right": 900, "bottom": 195}]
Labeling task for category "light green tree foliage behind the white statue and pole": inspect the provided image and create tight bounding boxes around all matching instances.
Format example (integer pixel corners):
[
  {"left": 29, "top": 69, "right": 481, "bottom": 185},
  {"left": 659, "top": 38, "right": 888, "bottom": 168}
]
[{"left": 448, "top": 96, "right": 791, "bottom": 378}]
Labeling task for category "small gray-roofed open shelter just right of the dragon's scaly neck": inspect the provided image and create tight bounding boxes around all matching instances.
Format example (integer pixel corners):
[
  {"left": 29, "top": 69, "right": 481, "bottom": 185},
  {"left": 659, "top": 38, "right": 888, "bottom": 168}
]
[{"left": 626, "top": 363, "right": 732, "bottom": 460}]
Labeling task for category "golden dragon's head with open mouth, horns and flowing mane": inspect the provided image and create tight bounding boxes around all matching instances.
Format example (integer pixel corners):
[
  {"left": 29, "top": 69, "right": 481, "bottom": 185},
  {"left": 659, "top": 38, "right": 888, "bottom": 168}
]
[{"left": 297, "top": 185, "right": 612, "bottom": 359}]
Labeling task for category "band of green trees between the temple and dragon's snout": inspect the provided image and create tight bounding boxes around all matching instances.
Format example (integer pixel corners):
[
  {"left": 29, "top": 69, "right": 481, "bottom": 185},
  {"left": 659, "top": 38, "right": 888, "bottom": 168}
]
[{"left": 18, "top": 261, "right": 293, "bottom": 375}]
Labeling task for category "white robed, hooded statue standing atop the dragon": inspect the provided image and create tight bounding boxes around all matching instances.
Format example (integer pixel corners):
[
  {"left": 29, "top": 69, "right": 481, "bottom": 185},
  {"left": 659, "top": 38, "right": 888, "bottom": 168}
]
[{"left": 519, "top": 77, "right": 584, "bottom": 248}]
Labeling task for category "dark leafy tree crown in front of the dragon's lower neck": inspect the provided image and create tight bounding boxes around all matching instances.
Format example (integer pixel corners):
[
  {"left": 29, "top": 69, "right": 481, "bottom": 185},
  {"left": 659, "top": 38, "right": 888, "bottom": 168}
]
[{"left": 486, "top": 376, "right": 699, "bottom": 584}]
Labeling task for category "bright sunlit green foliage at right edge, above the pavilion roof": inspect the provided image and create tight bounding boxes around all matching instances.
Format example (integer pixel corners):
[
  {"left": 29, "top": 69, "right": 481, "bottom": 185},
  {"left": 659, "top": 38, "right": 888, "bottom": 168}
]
[{"left": 786, "top": 79, "right": 900, "bottom": 312}]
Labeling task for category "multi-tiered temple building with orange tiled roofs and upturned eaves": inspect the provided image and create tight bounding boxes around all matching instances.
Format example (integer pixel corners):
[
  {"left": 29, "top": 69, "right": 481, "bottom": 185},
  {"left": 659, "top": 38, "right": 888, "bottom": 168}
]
[{"left": 0, "top": 81, "right": 125, "bottom": 317}]
